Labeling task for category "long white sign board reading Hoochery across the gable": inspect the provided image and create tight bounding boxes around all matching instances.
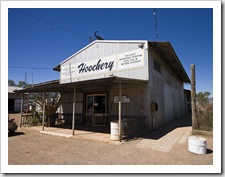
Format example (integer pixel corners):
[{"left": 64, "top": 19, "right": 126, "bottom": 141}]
[{"left": 60, "top": 48, "right": 144, "bottom": 83}]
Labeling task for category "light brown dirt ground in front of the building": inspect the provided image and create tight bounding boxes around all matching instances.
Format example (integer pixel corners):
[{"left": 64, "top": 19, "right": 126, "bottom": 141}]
[{"left": 8, "top": 114, "right": 213, "bottom": 168}]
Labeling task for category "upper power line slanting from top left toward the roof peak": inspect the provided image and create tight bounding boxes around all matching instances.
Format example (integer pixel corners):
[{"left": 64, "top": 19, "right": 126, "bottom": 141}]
[{"left": 10, "top": 9, "right": 89, "bottom": 39}]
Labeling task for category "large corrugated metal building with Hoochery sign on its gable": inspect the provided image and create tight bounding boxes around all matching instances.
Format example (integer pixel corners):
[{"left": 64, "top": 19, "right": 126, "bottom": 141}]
[{"left": 16, "top": 40, "right": 190, "bottom": 140}]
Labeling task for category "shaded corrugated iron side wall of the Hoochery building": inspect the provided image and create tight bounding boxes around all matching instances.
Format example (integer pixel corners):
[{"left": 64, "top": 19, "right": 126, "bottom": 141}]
[{"left": 149, "top": 47, "right": 185, "bottom": 129}]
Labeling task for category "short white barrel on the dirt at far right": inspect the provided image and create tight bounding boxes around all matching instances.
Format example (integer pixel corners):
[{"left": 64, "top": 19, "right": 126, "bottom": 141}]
[{"left": 188, "top": 136, "right": 207, "bottom": 154}]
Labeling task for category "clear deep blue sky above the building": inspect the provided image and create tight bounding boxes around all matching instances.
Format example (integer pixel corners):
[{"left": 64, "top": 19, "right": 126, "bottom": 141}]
[{"left": 8, "top": 8, "right": 213, "bottom": 94}]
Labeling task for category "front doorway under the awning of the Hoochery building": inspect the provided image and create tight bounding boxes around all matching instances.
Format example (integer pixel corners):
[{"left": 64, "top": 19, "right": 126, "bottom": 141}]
[{"left": 86, "top": 94, "right": 108, "bottom": 126}]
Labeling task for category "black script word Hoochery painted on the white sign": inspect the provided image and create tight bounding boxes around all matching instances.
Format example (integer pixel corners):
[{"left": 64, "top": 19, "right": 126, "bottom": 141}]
[{"left": 78, "top": 59, "right": 114, "bottom": 74}]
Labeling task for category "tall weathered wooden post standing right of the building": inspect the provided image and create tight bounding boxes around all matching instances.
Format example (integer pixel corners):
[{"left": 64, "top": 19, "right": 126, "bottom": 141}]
[{"left": 191, "top": 64, "right": 198, "bottom": 130}]
